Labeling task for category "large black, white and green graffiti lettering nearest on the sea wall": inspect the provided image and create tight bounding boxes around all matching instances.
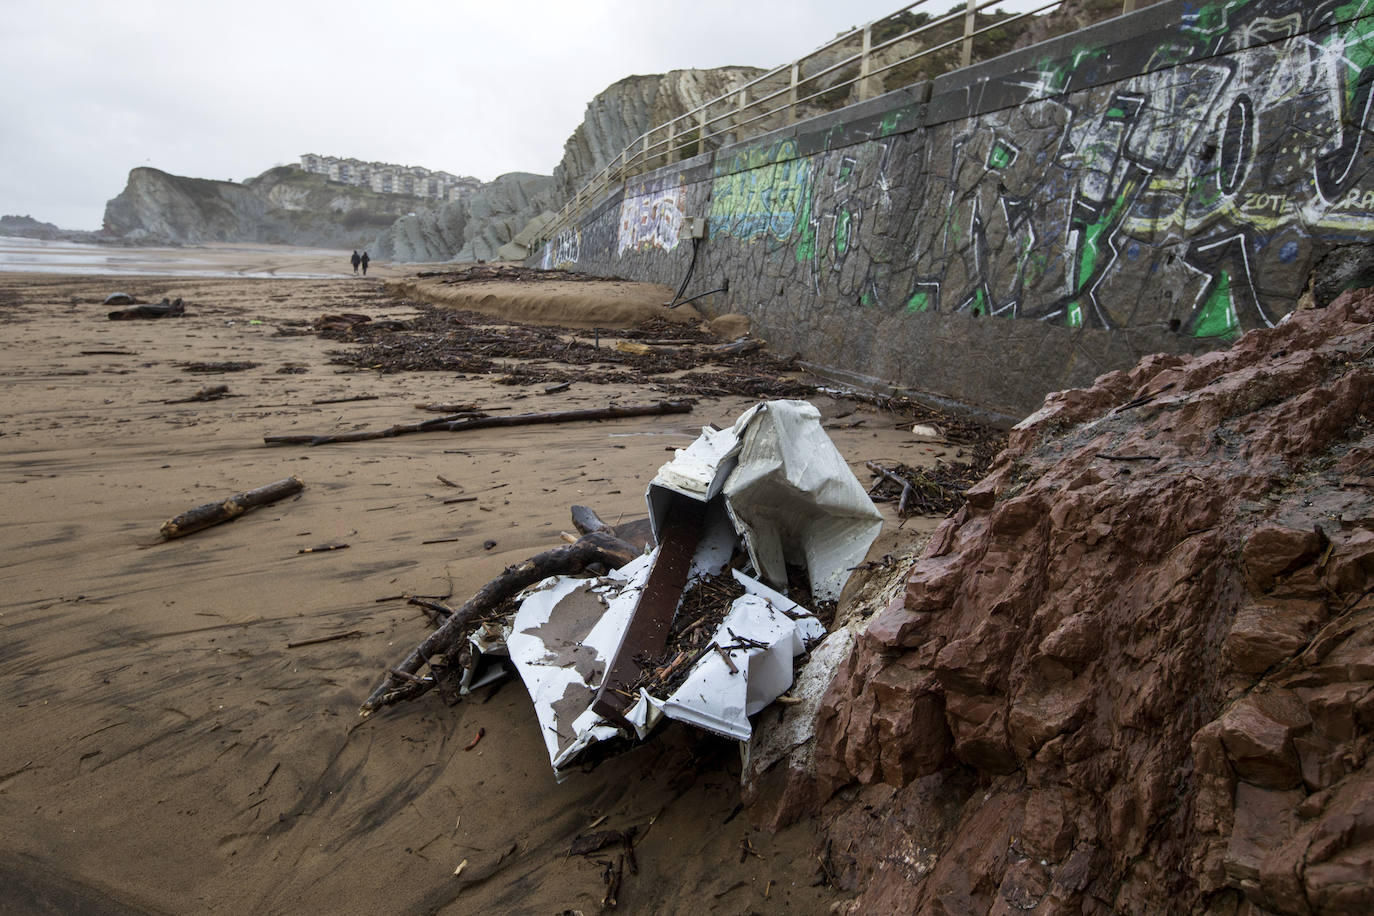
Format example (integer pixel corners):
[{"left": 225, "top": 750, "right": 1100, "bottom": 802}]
[{"left": 919, "top": 0, "right": 1374, "bottom": 336}]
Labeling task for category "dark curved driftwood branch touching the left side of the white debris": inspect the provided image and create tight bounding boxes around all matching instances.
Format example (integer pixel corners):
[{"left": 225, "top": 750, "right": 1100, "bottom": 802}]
[{"left": 359, "top": 521, "right": 638, "bottom": 717}]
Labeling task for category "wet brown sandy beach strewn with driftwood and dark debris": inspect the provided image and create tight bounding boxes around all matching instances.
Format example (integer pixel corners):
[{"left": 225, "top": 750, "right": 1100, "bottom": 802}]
[{"left": 0, "top": 249, "right": 955, "bottom": 913}]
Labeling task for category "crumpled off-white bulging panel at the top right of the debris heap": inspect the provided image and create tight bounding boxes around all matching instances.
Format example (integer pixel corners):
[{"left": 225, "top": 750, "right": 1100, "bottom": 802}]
[{"left": 721, "top": 401, "right": 882, "bottom": 600}]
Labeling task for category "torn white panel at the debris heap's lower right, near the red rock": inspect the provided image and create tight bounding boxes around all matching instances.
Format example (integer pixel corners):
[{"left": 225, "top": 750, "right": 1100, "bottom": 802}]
[{"left": 662, "top": 595, "right": 824, "bottom": 740}]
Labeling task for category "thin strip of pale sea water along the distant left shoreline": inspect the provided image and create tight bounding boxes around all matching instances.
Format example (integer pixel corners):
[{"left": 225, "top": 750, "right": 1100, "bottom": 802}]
[{"left": 0, "top": 236, "right": 340, "bottom": 280}]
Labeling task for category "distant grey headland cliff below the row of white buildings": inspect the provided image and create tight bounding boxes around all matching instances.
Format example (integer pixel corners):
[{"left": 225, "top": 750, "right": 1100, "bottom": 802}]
[{"left": 103, "top": 166, "right": 420, "bottom": 249}]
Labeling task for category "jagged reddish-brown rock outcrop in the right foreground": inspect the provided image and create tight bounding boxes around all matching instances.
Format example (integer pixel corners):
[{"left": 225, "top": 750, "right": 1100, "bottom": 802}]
[{"left": 812, "top": 298, "right": 1374, "bottom": 913}]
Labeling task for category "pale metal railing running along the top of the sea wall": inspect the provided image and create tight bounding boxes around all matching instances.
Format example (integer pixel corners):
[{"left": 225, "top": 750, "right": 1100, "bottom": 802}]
[{"left": 544, "top": 0, "right": 1077, "bottom": 238}]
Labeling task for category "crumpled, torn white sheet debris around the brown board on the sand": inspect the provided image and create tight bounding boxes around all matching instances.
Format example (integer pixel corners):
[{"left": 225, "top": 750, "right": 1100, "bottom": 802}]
[{"left": 506, "top": 401, "right": 882, "bottom": 773}]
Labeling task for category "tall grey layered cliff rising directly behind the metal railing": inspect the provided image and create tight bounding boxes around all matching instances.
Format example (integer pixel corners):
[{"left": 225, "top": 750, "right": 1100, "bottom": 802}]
[{"left": 554, "top": 67, "right": 764, "bottom": 206}]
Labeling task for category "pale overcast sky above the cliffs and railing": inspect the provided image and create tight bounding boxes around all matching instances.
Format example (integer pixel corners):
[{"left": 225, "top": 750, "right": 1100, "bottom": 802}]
[{"left": 0, "top": 0, "right": 1044, "bottom": 229}]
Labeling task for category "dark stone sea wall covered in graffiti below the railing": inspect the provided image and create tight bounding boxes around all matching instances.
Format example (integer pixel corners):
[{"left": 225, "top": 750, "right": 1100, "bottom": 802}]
[{"left": 532, "top": 0, "right": 1374, "bottom": 416}]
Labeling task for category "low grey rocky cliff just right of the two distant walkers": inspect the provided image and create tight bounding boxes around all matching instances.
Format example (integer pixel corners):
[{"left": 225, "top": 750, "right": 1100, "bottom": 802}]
[{"left": 371, "top": 172, "right": 554, "bottom": 261}]
